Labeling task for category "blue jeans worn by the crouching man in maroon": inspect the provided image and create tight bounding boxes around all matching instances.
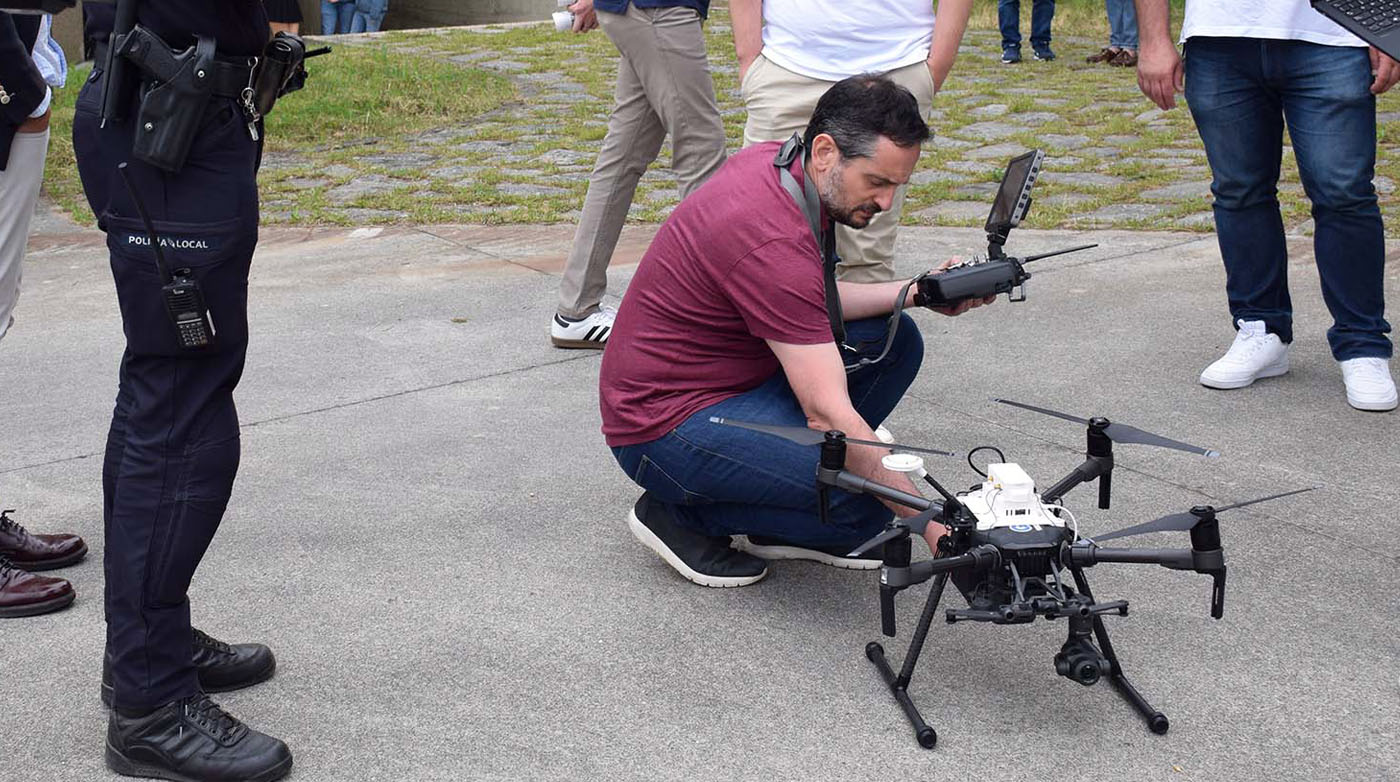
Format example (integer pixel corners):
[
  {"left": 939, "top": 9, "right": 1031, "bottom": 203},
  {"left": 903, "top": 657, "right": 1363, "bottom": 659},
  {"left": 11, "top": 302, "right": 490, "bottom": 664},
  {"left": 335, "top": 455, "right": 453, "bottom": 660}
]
[{"left": 613, "top": 315, "right": 924, "bottom": 546}]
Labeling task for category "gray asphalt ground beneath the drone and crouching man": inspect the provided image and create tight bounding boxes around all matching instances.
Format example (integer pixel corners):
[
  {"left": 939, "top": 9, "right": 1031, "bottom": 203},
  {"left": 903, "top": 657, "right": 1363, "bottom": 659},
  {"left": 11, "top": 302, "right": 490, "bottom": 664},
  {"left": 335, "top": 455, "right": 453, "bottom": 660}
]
[{"left": 0, "top": 205, "right": 1400, "bottom": 782}]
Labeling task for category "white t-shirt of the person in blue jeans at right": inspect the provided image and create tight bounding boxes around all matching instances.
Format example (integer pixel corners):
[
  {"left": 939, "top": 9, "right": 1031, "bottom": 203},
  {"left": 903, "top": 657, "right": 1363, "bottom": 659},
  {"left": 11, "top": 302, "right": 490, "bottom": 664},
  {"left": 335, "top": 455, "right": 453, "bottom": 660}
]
[{"left": 1182, "top": 0, "right": 1366, "bottom": 46}]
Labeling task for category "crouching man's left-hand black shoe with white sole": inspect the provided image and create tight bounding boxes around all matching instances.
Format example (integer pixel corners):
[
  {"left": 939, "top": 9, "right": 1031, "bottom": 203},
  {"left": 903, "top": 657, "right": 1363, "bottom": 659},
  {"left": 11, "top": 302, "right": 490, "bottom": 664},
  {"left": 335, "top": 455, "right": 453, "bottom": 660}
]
[{"left": 627, "top": 494, "right": 769, "bottom": 586}]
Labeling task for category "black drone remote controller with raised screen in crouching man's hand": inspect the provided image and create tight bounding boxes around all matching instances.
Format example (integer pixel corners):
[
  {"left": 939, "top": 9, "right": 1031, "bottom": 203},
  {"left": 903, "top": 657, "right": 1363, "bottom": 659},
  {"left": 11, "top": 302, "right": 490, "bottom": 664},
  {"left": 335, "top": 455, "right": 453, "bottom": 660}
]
[{"left": 916, "top": 150, "right": 1098, "bottom": 306}]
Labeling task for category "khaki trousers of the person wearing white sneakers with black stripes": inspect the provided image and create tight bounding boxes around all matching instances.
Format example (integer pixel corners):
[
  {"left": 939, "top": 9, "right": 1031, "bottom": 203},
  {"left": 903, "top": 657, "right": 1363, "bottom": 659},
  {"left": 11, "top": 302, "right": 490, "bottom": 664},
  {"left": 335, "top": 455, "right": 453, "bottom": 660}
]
[{"left": 559, "top": 4, "right": 725, "bottom": 318}]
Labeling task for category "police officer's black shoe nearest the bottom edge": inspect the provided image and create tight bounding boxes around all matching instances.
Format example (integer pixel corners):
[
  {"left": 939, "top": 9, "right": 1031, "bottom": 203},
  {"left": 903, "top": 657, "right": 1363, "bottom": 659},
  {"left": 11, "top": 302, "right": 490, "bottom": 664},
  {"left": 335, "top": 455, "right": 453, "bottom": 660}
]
[{"left": 106, "top": 692, "right": 291, "bottom": 782}]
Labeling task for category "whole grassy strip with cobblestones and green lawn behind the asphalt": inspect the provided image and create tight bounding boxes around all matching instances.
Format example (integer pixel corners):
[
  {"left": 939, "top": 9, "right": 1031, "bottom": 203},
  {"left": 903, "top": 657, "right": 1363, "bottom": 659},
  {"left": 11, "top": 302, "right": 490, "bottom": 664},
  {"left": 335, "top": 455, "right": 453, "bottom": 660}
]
[{"left": 38, "top": 0, "right": 1400, "bottom": 235}]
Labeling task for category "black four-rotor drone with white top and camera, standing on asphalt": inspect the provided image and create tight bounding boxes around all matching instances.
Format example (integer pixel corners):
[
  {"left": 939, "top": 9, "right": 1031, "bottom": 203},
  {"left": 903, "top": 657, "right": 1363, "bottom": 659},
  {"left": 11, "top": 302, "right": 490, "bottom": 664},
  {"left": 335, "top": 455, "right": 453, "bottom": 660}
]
[{"left": 711, "top": 399, "right": 1317, "bottom": 748}]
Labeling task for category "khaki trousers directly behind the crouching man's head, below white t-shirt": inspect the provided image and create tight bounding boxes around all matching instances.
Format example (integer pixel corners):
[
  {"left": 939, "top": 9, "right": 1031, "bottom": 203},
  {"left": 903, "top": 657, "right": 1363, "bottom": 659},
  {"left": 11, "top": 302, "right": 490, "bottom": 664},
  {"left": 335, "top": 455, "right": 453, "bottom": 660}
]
[{"left": 739, "top": 55, "right": 934, "bottom": 283}]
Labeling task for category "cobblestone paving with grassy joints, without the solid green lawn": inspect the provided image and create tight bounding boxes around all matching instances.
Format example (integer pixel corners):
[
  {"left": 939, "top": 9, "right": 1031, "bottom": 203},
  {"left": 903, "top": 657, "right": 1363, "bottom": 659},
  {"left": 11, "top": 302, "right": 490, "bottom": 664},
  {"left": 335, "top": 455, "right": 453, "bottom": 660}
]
[{"left": 262, "top": 7, "right": 1400, "bottom": 235}]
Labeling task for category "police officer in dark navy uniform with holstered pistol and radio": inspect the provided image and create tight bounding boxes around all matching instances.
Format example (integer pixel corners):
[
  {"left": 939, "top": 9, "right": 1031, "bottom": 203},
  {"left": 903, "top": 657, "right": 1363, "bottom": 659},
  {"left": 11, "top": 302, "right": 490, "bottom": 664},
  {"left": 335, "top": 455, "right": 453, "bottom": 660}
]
[{"left": 73, "top": 0, "right": 291, "bottom": 781}]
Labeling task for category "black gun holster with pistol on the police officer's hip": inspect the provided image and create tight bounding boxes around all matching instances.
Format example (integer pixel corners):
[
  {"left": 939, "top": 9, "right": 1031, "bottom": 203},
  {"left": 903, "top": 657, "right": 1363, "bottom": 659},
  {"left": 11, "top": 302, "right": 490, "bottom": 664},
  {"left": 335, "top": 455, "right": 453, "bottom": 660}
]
[{"left": 113, "top": 25, "right": 216, "bottom": 172}]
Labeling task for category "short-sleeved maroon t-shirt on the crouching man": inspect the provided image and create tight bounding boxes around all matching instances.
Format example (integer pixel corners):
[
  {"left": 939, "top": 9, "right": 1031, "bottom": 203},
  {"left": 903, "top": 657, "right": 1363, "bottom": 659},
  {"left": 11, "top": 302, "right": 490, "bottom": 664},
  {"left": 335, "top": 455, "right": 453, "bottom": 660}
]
[{"left": 599, "top": 143, "right": 833, "bottom": 448}]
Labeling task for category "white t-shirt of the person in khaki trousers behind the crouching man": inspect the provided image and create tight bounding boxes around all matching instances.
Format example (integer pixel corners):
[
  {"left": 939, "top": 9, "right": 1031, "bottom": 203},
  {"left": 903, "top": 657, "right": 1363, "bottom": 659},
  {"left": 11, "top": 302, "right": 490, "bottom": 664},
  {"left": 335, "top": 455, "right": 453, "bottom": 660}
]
[{"left": 763, "top": 0, "right": 934, "bottom": 81}]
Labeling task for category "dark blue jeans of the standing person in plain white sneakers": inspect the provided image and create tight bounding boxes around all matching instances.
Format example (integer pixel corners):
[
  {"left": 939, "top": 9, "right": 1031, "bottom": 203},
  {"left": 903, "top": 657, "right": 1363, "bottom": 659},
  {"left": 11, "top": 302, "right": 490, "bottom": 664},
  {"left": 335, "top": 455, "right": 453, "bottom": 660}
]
[{"left": 1186, "top": 38, "right": 1390, "bottom": 361}]
